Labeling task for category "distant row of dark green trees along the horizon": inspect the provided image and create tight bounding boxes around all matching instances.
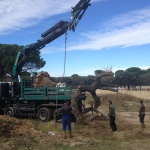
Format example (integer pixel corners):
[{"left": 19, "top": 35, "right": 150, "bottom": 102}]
[{"left": 52, "top": 67, "right": 150, "bottom": 88}]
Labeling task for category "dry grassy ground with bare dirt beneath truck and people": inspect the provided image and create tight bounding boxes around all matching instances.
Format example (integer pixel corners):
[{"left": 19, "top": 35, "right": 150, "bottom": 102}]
[{"left": 0, "top": 90, "right": 150, "bottom": 150}]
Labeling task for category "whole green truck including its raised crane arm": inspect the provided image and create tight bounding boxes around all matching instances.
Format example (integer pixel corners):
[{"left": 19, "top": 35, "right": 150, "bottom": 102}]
[{"left": 0, "top": 0, "right": 91, "bottom": 121}]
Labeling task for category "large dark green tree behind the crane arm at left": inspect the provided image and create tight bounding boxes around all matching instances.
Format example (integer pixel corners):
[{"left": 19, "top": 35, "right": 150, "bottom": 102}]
[{"left": 0, "top": 44, "right": 46, "bottom": 80}]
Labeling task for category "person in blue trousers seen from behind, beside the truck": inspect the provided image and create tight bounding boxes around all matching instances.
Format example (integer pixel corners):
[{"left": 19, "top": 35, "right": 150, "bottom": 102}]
[{"left": 61, "top": 102, "right": 72, "bottom": 139}]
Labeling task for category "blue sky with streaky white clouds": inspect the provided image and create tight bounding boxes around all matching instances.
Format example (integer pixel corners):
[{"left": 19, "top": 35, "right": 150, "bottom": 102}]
[{"left": 0, "top": 0, "right": 150, "bottom": 77}]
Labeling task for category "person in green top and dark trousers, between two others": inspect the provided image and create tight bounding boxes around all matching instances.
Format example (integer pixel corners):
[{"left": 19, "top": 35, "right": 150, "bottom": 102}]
[{"left": 108, "top": 101, "right": 117, "bottom": 132}]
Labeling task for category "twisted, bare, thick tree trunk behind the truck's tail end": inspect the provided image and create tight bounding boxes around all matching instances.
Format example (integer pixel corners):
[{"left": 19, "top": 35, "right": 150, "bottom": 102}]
[{"left": 72, "top": 73, "right": 118, "bottom": 124}]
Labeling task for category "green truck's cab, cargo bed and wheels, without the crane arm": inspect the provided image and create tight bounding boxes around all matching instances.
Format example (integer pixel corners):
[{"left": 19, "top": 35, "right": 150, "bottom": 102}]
[{"left": 0, "top": 81, "right": 72, "bottom": 121}]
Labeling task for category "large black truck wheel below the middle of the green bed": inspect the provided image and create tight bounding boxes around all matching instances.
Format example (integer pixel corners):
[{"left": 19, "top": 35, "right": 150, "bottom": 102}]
[{"left": 37, "top": 107, "right": 52, "bottom": 122}]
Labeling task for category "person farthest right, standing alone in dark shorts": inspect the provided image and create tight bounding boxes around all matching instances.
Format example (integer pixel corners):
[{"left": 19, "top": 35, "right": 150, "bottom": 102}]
[{"left": 139, "top": 100, "right": 145, "bottom": 128}]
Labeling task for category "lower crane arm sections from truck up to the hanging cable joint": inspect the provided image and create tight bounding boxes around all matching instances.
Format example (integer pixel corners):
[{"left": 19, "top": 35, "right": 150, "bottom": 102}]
[{"left": 12, "top": 21, "right": 69, "bottom": 81}]
